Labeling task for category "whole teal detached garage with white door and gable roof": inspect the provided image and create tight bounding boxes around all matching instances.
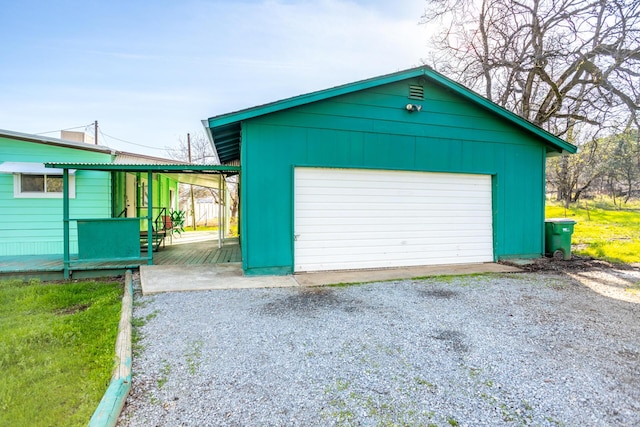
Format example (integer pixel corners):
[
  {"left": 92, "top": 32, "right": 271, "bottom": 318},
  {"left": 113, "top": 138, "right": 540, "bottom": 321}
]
[{"left": 208, "top": 67, "right": 576, "bottom": 274}]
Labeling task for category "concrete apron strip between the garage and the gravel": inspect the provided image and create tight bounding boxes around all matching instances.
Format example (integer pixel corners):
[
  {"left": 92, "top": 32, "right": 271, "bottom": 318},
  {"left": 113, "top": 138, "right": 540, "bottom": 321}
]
[{"left": 140, "top": 263, "right": 521, "bottom": 295}]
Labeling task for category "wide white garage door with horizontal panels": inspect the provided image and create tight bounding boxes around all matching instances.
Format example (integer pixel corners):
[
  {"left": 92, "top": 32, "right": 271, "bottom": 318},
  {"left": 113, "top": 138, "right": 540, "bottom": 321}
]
[{"left": 294, "top": 168, "right": 493, "bottom": 271}]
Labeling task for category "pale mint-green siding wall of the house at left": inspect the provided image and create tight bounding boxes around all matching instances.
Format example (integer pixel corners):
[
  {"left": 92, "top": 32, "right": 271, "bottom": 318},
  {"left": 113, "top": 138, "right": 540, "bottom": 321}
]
[{"left": 0, "top": 137, "right": 111, "bottom": 256}]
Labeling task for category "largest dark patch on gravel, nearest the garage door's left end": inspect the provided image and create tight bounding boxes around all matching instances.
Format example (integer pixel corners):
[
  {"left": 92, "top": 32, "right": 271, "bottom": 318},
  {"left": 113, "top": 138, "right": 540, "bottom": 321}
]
[{"left": 259, "top": 287, "right": 363, "bottom": 316}]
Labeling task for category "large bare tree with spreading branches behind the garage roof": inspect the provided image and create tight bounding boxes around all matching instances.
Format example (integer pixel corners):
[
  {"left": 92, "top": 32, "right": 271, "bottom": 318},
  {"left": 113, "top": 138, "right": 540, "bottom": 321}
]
[{"left": 422, "top": 0, "right": 640, "bottom": 201}]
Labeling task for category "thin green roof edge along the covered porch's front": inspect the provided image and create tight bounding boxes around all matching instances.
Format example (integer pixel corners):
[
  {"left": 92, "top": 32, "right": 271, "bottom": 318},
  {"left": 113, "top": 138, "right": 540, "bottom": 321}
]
[{"left": 44, "top": 162, "right": 241, "bottom": 173}]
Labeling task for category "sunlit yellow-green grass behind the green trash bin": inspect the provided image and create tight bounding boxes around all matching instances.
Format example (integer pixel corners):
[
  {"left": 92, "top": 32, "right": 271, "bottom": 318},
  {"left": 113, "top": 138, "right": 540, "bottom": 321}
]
[{"left": 546, "top": 200, "right": 640, "bottom": 263}]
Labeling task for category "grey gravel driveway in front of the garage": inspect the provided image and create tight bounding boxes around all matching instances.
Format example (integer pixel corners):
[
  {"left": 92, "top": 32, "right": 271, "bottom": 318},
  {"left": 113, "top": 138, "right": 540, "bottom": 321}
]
[{"left": 119, "top": 273, "right": 640, "bottom": 426}]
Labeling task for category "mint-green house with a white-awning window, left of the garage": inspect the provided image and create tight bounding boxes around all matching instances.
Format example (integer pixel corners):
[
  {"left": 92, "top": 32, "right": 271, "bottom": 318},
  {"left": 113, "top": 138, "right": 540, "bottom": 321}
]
[{"left": 0, "top": 130, "right": 178, "bottom": 262}]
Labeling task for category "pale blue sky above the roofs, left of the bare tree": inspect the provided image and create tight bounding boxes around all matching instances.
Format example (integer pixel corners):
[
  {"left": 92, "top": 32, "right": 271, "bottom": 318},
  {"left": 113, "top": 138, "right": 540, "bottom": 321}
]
[{"left": 0, "top": 0, "right": 428, "bottom": 157}]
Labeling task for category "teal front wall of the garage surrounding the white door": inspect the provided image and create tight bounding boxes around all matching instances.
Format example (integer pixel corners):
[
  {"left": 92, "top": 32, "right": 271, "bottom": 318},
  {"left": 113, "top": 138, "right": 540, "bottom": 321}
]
[{"left": 241, "top": 79, "right": 545, "bottom": 274}]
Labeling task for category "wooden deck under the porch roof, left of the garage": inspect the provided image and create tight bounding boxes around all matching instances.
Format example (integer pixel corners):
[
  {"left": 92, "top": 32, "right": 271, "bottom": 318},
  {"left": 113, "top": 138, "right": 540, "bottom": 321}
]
[{"left": 0, "top": 233, "right": 242, "bottom": 280}]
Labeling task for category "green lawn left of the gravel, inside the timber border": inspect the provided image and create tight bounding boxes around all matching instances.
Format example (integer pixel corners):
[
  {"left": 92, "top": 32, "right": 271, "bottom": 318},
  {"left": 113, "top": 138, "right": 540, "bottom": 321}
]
[{"left": 0, "top": 280, "right": 123, "bottom": 426}]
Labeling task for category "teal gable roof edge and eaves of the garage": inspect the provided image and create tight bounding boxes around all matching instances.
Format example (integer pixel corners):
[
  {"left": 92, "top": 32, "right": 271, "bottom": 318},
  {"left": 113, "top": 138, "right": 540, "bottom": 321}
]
[{"left": 202, "top": 66, "right": 577, "bottom": 164}]
